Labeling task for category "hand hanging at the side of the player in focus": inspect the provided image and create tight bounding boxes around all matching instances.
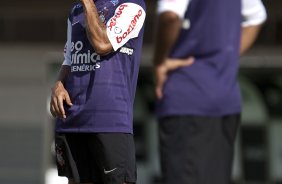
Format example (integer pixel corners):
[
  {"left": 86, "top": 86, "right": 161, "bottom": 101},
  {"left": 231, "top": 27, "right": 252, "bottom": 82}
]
[{"left": 50, "top": 81, "right": 72, "bottom": 118}]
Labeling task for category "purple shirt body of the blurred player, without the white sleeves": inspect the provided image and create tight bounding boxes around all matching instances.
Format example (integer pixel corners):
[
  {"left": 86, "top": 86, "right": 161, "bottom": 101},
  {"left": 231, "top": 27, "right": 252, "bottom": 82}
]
[{"left": 157, "top": 0, "right": 242, "bottom": 117}]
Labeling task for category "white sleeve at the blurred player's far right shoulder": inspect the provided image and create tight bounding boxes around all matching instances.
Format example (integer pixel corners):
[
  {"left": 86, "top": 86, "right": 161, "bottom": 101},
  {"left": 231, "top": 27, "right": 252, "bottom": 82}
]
[{"left": 242, "top": 0, "right": 267, "bottom": 27}]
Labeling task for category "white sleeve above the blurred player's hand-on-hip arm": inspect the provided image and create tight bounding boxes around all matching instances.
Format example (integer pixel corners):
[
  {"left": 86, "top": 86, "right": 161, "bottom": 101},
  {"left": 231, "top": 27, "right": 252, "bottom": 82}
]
[{"left": 157, "top": 0, "right": 190, "bottom": 19}]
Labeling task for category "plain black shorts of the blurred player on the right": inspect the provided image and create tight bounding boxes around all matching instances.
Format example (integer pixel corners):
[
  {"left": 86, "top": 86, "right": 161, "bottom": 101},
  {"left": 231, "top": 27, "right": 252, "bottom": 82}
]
[{"left": 159, "top": 114, "right": 240, "bottom": 184}]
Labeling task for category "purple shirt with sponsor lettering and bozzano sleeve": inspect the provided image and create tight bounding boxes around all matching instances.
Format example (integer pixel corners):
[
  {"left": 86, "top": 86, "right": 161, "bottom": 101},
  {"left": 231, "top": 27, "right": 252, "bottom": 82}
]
[{"left": 56, "top": 0, "right": 145, "bottom": 133}]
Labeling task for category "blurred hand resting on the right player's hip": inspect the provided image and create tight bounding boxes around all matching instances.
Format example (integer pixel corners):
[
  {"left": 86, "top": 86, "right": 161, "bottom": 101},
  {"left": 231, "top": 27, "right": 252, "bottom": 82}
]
[{"left": 155, "top": 57, "right": 194, "bottom": 99}]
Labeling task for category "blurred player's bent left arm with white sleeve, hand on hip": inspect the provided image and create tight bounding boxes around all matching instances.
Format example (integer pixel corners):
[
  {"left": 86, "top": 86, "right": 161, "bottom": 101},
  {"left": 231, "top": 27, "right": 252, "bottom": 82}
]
[{"left": 153, "top": 0, "right": 193, "bottom": 99}]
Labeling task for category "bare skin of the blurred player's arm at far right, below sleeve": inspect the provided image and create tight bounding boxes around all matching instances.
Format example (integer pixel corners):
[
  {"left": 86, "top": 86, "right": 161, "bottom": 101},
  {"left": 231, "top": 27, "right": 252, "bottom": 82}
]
[{"left": 240, "top": 25, "right": 261, "bottom": 55}]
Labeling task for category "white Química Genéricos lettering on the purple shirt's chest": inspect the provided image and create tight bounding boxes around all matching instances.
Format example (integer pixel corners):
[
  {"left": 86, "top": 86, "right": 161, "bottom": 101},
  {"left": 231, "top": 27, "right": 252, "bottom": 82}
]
[{"left": 71, "top": 41, "right": 101, "bottom": 72}]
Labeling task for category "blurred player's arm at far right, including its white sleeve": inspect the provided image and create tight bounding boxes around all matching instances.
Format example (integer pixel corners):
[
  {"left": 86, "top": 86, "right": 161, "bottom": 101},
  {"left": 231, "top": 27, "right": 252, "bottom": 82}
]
[{"left": 240, "top": 0, "right": 267, "bottom": 55}]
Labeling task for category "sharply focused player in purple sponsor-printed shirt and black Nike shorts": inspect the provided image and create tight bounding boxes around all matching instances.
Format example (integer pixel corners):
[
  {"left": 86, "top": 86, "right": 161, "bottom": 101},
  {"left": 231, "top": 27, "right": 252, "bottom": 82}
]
[{"left": 50, "top": 0, "right": 146, "bottom": 184}]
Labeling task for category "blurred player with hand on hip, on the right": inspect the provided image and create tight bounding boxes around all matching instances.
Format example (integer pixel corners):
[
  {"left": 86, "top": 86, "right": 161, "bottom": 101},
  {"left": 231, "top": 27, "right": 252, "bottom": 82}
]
[{"left": 154, "top": 0, "right": 266, "bottom": 184}]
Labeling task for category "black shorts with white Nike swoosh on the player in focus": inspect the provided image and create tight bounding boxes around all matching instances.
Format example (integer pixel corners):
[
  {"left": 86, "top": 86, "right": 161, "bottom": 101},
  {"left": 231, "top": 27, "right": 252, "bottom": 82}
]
[{"left": 55, "top": 133, "right": 136, "bottom": 184}]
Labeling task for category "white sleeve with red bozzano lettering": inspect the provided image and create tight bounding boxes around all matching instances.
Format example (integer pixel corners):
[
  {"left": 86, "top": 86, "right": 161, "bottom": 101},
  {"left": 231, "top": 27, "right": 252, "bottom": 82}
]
[{"left": 107, "top": 3, "right": 146, "bottom": 51}]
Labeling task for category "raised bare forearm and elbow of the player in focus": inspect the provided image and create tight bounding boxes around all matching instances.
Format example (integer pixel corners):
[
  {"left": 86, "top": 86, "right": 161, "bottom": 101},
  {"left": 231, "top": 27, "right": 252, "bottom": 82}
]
[{"left": 81, "top": 0, "right": 113, "bottom": 55}]
